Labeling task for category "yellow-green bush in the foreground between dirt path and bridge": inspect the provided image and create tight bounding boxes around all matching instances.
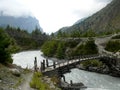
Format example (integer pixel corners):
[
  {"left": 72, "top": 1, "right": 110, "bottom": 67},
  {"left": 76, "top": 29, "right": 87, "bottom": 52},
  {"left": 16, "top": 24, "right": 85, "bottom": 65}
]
[{"left": 30, "top": 72, "right": 61, "bottom": 90}]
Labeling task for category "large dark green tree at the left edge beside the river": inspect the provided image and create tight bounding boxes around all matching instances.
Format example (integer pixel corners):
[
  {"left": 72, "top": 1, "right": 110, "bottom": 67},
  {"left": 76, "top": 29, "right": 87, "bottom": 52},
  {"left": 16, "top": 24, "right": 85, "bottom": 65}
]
[{"left": 0, "top": 28, "right": 12, "bottom": 63}]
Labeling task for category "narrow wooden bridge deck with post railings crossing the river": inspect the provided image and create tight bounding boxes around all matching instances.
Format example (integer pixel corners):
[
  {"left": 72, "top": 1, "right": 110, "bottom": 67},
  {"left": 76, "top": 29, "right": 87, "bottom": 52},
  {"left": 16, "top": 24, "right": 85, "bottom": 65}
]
[{"left": 38, "top": 55, "right": 117, "bottom": 72}]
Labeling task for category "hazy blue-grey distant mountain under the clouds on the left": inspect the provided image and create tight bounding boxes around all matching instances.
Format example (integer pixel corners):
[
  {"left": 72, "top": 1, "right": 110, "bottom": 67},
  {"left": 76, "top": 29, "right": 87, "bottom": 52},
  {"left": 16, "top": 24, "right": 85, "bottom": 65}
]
[{"left": 0, "top": 15, "right": 42, "bottom": 32}]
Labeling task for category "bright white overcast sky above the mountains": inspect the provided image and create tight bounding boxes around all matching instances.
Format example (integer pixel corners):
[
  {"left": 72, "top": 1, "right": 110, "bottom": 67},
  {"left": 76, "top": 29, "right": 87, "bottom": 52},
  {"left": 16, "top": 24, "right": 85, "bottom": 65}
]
[{"left": 0, "top": 0, "right": 112, "bottom": 33}]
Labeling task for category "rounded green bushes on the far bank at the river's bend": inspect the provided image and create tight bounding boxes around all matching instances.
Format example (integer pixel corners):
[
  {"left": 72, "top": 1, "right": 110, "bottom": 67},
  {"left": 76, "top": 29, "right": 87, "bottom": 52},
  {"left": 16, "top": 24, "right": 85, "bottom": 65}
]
[{"left": 42, "top": 40, "right": 65, "bottom": 59}]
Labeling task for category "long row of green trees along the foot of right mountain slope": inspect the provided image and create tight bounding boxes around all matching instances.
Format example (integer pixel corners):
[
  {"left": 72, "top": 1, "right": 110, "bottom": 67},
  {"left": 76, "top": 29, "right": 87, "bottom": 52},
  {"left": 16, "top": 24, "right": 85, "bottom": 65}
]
[{"left": 51, "top": 29, "right": 120, "bottom": 38}]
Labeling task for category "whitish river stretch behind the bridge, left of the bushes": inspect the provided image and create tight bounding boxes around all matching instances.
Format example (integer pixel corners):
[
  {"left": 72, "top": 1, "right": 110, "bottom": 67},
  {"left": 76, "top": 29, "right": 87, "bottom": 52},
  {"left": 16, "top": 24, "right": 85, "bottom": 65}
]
[{"left": 12, "top": 50, "right": 52, "bottom": 68}]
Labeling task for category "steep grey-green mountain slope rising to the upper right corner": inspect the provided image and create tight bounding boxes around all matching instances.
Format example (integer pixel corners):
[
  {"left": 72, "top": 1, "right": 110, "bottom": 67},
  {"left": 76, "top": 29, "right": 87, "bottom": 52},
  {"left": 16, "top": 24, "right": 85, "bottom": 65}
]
[{"left": 61, "top": 0, "right": 120, "bottom": 33}]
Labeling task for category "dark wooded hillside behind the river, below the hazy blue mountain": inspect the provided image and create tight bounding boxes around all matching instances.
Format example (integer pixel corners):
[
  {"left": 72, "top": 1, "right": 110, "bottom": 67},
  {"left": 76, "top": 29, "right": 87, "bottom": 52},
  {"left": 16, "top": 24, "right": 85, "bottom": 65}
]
[{"left": 5, "top": 25, "right": 48, "bottom": 50}]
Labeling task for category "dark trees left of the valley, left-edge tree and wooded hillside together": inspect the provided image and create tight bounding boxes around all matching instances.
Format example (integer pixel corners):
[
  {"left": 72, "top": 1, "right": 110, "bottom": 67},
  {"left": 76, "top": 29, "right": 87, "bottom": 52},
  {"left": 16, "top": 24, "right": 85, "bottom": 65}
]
[{"left": 0, "top": 25, "right": 49, "bottom": 63}]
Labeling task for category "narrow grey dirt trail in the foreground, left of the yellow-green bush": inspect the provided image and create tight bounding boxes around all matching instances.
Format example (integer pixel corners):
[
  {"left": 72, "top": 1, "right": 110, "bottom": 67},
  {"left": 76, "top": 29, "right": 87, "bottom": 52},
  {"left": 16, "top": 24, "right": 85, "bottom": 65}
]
[{"left": 20, "top": 72, "right": 34, "bottom": 90}]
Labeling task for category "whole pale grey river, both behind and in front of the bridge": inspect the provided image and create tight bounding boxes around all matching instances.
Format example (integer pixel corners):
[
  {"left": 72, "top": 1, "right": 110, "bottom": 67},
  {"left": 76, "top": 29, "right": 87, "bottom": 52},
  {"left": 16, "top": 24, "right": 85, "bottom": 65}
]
[{"left": 12, "top": 51, "right": 120, "bottom": 90}]
